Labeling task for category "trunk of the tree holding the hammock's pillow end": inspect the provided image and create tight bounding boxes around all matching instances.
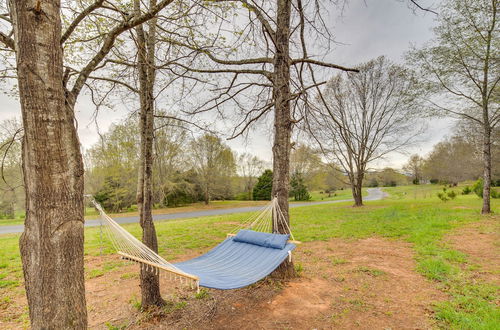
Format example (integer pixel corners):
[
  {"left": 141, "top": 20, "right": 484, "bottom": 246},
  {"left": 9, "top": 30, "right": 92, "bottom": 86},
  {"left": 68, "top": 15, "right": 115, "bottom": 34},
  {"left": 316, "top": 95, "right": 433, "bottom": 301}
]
[{"left": 272, "top": 0, "right": 296, "bottom": 279}]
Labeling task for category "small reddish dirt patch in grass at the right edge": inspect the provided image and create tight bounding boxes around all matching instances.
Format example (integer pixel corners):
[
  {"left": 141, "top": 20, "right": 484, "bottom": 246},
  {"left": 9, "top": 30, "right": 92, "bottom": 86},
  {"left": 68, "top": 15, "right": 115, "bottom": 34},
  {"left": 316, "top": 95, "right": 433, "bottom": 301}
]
[{"left": 448, "top": 219, "right": 500, "bottom": 285}]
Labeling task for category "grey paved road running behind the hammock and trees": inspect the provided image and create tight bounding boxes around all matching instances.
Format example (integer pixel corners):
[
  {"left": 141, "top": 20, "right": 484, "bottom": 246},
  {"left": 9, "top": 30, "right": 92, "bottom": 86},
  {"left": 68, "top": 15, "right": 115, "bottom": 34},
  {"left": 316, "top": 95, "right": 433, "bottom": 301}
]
[{"left": 0, "top": 188, "right": 386, "bottom": 235}]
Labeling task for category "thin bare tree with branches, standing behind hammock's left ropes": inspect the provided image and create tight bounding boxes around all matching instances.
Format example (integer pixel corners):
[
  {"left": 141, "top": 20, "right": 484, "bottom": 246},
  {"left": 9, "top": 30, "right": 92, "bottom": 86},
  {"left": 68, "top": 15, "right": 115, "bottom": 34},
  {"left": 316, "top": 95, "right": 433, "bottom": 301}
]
[{"left": 75, "top": 0, "right": 212, "bottom": 309}]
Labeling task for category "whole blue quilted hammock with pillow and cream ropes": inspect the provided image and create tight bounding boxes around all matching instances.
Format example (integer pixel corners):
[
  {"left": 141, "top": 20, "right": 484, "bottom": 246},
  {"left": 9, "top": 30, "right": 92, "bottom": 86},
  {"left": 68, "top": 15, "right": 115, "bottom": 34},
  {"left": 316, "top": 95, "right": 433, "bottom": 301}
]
[{"left": 86, "top": 196, "right": 300, "bottom": 290}]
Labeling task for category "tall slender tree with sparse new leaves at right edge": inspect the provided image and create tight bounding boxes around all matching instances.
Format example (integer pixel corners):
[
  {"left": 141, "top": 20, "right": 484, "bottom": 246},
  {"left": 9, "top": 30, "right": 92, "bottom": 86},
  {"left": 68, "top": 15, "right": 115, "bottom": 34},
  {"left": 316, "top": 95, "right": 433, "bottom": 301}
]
[{"left": 409, "top": 0, "right": 500, "bottom": 213}]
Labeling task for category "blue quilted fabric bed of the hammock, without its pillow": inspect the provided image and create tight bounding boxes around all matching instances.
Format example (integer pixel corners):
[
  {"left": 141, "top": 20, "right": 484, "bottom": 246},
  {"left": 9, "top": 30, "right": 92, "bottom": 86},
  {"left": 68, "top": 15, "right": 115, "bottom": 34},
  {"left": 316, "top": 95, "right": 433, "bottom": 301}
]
[{"left": 174, "top": 232, "right": 295, "bottom": 290}]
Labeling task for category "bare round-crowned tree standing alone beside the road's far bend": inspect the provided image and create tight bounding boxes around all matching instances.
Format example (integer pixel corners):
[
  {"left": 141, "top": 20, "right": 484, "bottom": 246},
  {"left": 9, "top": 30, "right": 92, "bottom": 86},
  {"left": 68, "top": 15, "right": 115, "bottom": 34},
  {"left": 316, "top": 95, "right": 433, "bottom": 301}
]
[{"left": 307, "top": 57, "right": 423, "bottom": 206}]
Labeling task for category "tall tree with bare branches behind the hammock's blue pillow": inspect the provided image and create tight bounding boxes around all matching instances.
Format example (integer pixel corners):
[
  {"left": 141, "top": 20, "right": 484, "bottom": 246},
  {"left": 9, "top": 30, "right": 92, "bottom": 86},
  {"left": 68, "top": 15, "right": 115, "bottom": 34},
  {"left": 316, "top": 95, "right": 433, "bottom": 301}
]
[{"left": 166, "top": 0, "right": 356, "bottom": 277}]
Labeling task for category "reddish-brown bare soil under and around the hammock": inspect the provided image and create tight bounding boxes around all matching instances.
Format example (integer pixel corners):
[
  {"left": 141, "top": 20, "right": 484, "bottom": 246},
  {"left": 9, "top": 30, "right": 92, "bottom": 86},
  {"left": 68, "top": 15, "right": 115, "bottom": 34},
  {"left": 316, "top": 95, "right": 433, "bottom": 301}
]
[{"left": 0, "top": 238, "right": 446, "bottom": 329}]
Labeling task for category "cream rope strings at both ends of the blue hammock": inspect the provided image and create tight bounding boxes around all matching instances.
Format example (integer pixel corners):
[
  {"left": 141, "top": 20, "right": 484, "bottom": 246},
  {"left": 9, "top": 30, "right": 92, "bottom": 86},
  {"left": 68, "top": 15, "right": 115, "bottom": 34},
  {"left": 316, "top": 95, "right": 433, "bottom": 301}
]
[{"left": 86, "top": 195, "right": 295, "bottom": 290}]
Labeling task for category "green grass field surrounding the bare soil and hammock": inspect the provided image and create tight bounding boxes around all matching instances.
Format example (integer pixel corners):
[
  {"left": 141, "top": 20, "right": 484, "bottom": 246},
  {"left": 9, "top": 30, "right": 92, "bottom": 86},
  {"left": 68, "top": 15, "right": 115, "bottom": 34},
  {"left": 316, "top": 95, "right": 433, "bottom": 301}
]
[{"left": 0, "top": 185, "right": 500, "bottom": 329}]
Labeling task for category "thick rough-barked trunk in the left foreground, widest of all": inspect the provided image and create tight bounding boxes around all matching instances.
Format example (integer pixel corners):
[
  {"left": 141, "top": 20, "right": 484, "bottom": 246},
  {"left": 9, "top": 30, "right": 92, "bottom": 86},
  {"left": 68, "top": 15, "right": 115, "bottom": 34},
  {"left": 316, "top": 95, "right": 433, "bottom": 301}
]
[{"left": 10, "top": 0, "right": 87, "bottom": 329}]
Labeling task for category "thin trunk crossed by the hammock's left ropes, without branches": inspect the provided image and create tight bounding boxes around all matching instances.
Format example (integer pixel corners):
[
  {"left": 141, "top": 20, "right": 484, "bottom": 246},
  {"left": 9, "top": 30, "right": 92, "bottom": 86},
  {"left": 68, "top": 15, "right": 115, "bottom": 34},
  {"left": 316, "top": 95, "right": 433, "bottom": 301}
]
[{"left": 135, "top": 0, "right": 164, "bottom": 309}]
